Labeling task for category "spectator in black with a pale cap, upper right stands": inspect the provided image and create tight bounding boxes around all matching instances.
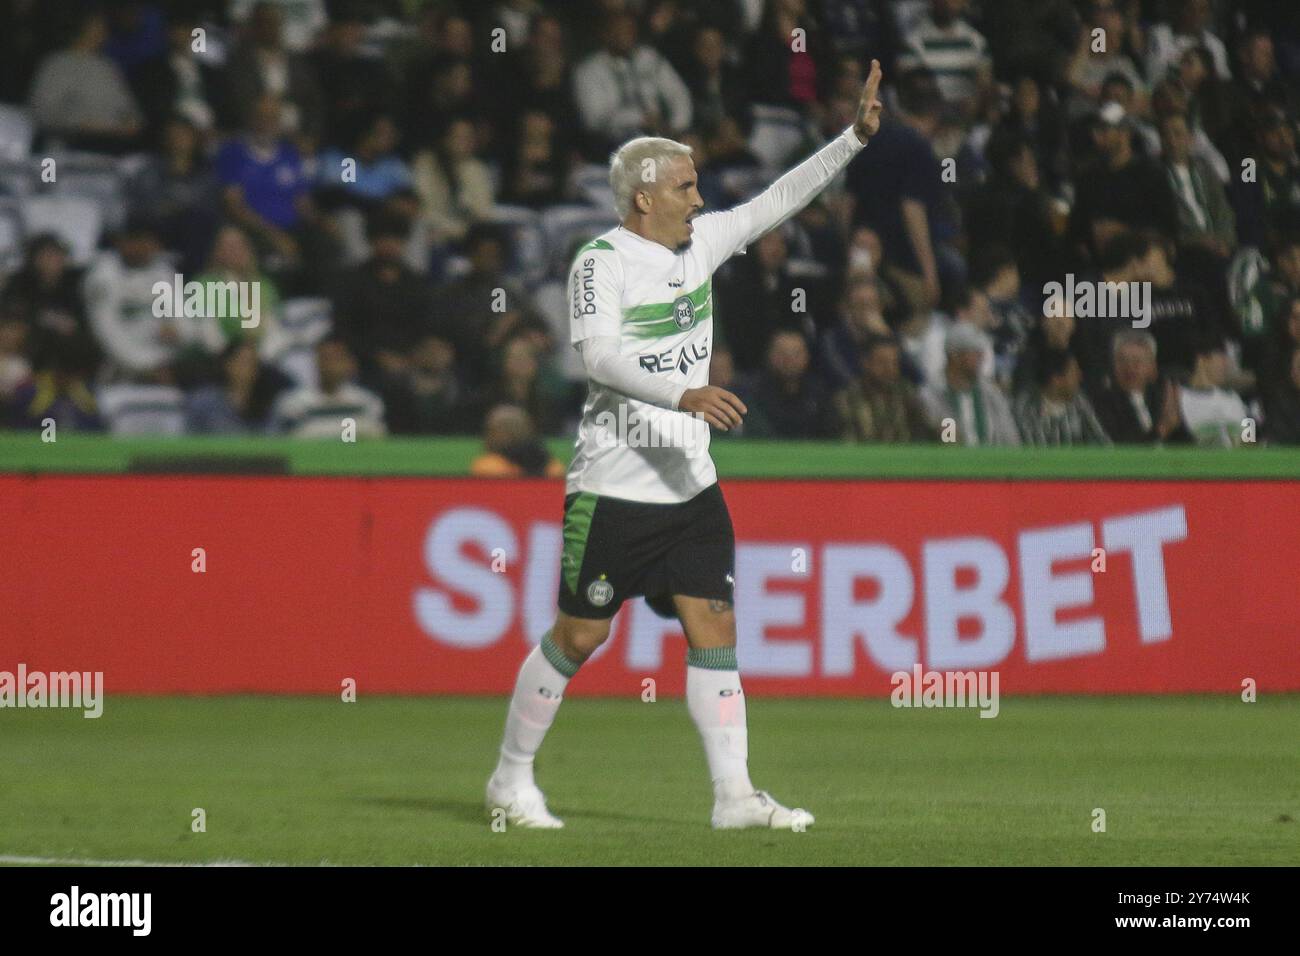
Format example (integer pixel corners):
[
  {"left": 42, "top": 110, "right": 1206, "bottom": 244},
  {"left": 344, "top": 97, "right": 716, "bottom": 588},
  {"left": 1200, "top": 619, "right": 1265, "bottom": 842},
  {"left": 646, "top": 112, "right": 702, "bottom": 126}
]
[{"left": 1070, "top": 103, "right": 1178, "bottom": 254}]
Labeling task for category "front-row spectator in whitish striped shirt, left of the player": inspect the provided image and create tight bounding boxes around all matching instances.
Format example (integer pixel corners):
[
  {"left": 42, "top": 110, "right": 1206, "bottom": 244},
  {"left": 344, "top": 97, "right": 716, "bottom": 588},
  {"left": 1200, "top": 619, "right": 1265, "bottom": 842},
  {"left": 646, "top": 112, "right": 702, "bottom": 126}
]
[{"left": 270, "top": 336, "right": 387, "bottom": 441}]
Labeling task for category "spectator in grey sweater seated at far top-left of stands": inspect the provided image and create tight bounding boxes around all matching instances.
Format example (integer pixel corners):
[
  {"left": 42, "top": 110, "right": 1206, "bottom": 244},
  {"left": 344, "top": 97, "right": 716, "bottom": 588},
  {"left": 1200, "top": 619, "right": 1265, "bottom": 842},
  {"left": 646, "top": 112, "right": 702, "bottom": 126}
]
[{"left": 31, "top": 8, "right": 144, "bottom": 153}]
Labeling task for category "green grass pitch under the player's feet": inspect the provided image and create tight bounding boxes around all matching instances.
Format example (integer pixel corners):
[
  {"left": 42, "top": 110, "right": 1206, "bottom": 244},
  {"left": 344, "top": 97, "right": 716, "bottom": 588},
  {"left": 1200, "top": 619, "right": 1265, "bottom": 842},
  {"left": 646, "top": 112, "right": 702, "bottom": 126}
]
[{"left": 0, "top": 688, "right": 1300, "bottom": 866}]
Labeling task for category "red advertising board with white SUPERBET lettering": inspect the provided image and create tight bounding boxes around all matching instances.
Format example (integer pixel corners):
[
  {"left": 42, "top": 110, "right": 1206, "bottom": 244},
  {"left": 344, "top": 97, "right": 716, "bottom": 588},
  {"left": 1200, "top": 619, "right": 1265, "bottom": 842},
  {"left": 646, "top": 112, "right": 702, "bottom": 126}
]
[{"left": 0, "top": 476, "right": 1300, "bottom": 696}]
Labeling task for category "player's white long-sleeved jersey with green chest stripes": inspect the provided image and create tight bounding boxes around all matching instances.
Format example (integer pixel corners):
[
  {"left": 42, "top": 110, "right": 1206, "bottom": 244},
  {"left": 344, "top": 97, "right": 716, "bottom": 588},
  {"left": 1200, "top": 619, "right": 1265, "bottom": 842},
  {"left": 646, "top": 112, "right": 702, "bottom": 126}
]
[{"left": 566, "top": 127, "right": 862, "bottom": 503}]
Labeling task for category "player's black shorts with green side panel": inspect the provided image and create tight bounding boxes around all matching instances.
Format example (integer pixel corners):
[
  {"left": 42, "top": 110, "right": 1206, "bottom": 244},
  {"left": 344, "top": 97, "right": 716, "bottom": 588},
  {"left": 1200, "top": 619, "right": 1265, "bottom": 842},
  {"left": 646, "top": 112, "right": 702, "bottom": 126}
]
[{"left": 559, "top": 483, "right": 736, "bottom": 619}]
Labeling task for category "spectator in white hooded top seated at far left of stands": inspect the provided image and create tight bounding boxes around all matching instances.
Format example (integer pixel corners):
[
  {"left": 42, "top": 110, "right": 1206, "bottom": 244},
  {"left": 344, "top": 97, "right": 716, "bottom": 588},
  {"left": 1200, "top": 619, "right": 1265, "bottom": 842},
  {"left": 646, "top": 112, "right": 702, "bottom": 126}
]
[{"left": 85, "top": 220, "right": 225, "bottom": 385}]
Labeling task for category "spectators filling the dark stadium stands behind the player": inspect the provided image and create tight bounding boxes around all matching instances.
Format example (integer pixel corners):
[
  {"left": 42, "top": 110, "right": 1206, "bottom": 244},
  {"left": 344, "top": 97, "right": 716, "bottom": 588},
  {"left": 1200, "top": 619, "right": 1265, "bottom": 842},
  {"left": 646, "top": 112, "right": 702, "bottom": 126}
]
[{"left": 0, "top": 0, "right": 1300, "bottom": 473}]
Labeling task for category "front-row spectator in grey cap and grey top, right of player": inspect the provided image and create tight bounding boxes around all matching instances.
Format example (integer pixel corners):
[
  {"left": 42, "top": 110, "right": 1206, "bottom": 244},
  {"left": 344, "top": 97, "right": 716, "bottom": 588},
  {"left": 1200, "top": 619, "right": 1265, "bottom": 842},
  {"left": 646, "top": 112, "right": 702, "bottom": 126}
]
[{"left": 920, "top": 323, "right": 1021, "bottom": 446}]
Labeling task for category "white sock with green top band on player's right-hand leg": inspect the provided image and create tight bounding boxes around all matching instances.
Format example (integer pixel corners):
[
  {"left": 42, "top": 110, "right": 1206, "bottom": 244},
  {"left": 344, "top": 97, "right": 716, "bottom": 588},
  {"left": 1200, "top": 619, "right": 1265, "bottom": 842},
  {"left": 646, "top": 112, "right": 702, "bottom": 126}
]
[{"left": 686, "top": 648, "right": 754, "bottom": 800}]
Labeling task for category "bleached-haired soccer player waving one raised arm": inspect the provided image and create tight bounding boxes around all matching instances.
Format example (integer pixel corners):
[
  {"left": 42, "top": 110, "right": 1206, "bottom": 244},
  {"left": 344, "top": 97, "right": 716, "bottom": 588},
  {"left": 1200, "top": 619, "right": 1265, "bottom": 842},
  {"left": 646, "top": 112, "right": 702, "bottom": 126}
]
[{"left": 486, "top": 60, "right": 881, "bottom": 830}]
